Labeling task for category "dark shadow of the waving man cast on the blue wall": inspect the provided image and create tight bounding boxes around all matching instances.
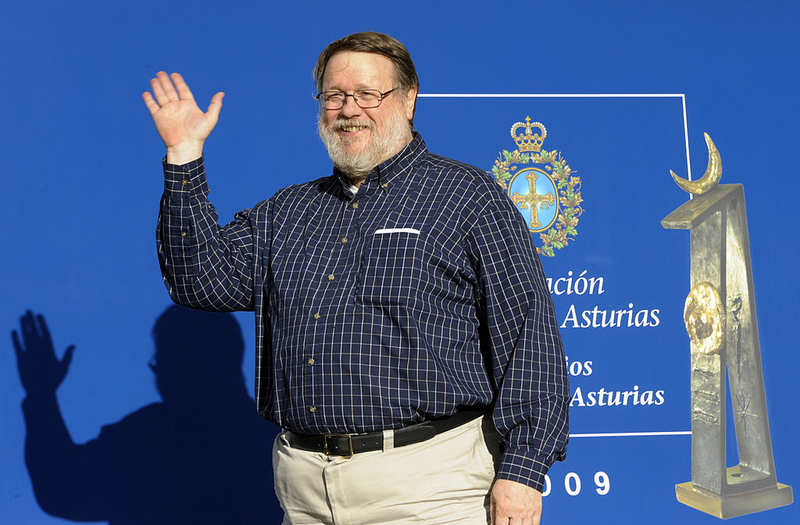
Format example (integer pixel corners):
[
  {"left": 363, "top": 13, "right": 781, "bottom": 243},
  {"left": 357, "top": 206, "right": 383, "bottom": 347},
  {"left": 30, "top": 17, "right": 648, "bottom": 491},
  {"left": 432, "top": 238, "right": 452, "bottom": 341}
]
[{"left": 12, "top": 306, "right": 282, "bottom": 525}]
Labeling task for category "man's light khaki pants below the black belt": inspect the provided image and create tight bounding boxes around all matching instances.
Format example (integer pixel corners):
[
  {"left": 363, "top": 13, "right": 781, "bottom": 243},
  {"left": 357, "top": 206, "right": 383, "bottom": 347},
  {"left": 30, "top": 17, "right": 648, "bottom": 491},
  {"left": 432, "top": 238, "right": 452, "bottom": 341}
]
[{"left": 272, "top": 417, "right": 499, "bottom": 525}]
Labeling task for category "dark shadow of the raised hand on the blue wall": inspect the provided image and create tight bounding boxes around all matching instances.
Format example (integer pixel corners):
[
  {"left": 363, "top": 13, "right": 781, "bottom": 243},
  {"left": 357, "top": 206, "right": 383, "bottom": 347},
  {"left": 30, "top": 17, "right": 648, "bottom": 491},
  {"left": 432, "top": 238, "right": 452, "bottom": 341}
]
[{"left": 11, "top": 310, "right": 75, "bottom": 396}]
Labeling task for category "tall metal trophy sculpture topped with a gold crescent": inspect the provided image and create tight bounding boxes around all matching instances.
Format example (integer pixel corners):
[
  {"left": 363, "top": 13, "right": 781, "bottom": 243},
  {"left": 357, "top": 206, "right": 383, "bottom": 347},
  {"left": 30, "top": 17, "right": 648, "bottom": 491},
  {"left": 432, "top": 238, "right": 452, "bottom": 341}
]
[{"left": 661, "top": 134, "right": 792, "bottom": 518}]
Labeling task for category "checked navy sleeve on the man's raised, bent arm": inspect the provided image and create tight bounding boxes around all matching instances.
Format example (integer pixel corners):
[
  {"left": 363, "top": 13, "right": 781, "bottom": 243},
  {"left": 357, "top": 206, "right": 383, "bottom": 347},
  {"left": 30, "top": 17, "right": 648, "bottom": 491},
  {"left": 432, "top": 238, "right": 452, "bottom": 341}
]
[{"left": 156, "top": 158, "right": 254, "bottom": 311}]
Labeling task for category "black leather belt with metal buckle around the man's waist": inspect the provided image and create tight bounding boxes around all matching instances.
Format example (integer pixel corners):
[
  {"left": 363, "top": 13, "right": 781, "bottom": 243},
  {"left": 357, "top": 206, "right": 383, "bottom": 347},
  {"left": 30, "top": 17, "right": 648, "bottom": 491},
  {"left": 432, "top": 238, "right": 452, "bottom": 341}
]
[{"left": 286, "top": 407, "right": 487, "bottom": 458}]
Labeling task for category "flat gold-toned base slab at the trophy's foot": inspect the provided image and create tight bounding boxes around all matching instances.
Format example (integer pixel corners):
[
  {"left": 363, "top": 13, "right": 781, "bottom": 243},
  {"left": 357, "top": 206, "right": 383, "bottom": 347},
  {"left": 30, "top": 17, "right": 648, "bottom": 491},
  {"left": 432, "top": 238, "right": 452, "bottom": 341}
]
[{"left": 675, "top": 481, "right": 794, "bottom": 519}]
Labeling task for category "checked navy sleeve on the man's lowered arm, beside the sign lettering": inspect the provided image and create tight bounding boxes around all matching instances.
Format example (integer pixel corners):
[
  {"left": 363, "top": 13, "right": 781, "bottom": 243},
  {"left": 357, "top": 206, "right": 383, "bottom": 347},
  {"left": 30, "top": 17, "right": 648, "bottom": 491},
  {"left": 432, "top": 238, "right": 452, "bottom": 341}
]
[{"left": 468, "top": 177, "right": 570, "bottom": 491}]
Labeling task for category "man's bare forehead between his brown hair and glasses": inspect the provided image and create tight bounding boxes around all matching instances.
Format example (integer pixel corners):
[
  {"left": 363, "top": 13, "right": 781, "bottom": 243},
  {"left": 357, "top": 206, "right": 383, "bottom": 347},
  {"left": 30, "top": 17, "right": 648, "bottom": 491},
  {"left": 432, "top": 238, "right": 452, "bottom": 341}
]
[{"left": 322, "top": 51, "right": 394, "bottom": 90}]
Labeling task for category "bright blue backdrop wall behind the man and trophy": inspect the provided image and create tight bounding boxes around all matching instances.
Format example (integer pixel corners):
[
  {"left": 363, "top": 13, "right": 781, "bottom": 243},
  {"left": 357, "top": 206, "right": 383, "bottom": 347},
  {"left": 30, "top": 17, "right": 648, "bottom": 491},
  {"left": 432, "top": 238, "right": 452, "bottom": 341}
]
[{"left": 0, "top": 1, "right": 800, "bottom": 524}]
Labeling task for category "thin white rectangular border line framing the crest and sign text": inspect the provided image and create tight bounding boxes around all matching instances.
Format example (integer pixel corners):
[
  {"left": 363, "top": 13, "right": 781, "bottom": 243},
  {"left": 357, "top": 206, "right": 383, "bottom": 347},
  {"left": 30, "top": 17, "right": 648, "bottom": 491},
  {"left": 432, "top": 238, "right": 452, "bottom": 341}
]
[{"left": 419, "top": 93, "right": 692, "bottom": 438}]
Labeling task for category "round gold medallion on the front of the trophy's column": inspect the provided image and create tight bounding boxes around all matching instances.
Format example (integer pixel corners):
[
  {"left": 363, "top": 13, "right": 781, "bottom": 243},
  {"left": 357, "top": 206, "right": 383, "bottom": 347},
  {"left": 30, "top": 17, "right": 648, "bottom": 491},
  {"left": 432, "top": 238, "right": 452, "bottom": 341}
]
[{"left": 683, "top": 282, "right": 725, "bottom": 354}]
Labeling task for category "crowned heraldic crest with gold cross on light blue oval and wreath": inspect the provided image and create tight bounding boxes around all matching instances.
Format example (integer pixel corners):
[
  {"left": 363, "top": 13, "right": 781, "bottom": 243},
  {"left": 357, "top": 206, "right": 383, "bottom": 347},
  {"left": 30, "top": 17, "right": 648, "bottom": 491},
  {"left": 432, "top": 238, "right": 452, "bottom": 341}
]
[{"left": 492, "top": 117, "right": 583, "bottom": 257}]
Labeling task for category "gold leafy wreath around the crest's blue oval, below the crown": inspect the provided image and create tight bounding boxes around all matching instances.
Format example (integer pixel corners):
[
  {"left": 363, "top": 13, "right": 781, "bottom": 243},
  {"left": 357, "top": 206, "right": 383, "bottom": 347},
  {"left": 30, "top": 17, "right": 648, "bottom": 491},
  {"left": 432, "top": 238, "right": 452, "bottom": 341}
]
[{"left": 492, "top": 150, "right": 583, "bottom": 257}]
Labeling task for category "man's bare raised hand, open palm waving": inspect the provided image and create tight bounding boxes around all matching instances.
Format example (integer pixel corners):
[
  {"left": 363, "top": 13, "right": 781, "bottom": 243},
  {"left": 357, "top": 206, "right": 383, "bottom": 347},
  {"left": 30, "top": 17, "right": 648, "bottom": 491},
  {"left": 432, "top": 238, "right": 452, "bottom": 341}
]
[{"left": 142, "top": 71, "right": 225, "bottom": 164}]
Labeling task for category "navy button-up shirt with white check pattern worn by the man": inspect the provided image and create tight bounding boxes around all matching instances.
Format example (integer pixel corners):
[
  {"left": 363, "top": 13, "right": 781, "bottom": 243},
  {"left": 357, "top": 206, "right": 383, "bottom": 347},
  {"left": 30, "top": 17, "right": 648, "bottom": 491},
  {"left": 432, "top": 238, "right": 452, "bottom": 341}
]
[{"left": 157, "top": 134, "right": 569, "bottom": 490}]
